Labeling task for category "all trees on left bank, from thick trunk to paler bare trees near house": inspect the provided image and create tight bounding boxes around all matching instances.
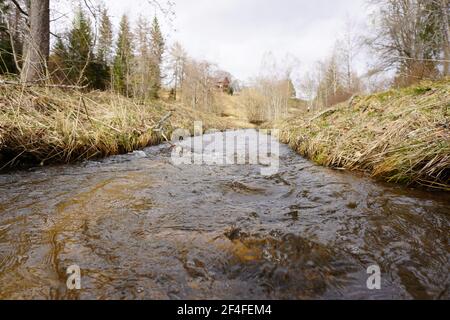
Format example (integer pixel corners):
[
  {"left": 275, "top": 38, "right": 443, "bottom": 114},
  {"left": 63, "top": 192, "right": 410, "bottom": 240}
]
[{"left": 0, "top": 0, "right": 234, "bottom": 111}]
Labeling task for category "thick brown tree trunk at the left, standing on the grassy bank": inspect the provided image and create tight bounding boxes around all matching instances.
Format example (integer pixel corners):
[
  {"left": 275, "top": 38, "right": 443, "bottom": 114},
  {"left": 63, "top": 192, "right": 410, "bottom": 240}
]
[{"left": 21, "top": 0, "right": 50, "bottom": 82}]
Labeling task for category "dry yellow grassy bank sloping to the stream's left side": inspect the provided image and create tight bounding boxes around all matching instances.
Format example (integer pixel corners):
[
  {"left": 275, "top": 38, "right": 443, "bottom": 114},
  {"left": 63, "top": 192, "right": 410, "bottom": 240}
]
[{"left": 0, "top": 86, "right": 232, "bottom": 168}]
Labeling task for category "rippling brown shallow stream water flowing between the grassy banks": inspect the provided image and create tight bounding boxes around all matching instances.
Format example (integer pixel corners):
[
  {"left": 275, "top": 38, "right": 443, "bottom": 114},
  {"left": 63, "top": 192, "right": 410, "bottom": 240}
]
[{"left": 0, "top": 131, "right": 450, "bottom": 299}]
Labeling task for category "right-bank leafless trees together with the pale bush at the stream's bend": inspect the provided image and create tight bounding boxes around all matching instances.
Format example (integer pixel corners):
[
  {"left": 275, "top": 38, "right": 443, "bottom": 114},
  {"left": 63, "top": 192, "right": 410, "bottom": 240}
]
[{"left": 243, "top": 0, "right": 450, "bottom": 122}]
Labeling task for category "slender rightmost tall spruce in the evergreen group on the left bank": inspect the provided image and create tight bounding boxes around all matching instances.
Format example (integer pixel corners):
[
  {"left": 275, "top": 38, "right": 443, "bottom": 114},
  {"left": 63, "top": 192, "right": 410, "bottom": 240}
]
[{"left": 150, "top": 17, "right": 165, "bottom": 98}]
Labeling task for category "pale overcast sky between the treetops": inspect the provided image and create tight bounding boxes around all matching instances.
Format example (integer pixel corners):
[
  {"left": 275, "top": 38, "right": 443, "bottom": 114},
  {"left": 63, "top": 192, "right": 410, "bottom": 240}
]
[{"left": 58, "top": 0, "right": 367, "bottom": 80}]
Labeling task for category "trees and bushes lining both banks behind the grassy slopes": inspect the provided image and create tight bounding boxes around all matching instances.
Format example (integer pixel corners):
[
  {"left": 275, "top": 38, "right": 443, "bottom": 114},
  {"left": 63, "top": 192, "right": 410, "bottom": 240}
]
[{"left": 0, "top": 0, "right": 450, "bottom": 117}]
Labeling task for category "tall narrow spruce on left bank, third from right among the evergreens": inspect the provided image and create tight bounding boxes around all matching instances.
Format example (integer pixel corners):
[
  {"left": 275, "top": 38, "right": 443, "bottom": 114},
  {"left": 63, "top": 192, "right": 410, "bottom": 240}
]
[{"left": 113, "top": 15, "right": 133, "bottom": 96}]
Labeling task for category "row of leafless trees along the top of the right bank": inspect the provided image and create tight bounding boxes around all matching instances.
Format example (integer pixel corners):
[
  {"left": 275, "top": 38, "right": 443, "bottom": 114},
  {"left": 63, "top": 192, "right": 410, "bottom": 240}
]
[{"left": 300, "top": 0, "right": 450, "bottom": 110}]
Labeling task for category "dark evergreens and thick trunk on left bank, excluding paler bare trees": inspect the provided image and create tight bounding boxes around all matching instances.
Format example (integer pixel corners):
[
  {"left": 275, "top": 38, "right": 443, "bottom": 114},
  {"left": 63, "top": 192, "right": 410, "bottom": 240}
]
[{"left": 0, "top": 0, "right": 165, "bottom": 99}]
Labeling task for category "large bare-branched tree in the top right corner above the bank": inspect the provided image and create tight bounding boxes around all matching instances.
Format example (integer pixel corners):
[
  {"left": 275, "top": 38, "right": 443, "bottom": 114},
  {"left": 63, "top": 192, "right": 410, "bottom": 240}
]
[{"left": 367, "top": 0, "right": 449, "bottom": 85}]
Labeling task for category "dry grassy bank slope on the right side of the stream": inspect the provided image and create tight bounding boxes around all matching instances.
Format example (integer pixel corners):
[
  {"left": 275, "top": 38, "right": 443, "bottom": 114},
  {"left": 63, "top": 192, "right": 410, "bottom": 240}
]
[{"left": 277, "top": 81, "right": 450, "bottom": 191}]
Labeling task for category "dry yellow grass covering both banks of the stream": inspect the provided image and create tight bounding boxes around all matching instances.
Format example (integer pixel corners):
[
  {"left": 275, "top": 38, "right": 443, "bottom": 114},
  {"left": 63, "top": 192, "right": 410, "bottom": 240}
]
[{"left": 0, "top": 80, "right": 450, "bottom": 191}]
